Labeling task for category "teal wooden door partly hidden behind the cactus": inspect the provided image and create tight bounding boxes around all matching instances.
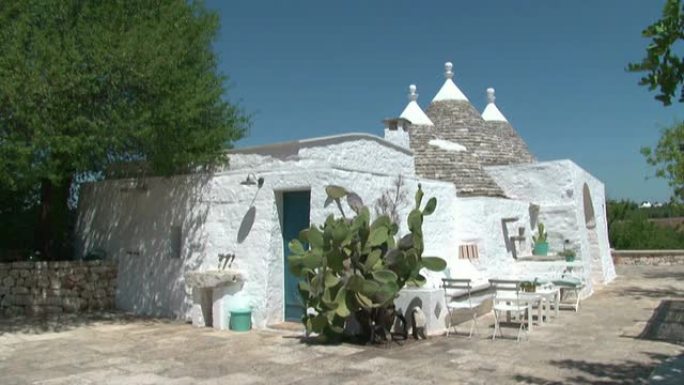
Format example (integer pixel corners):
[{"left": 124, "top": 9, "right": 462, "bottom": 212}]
[{"left": 283, "top": 191, "right": 311, "bottom": 321}]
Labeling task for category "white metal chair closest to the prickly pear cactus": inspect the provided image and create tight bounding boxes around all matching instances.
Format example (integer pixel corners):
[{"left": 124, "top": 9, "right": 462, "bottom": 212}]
[{"left": 442, "top": 278, "right": 491, "bottom": 338}]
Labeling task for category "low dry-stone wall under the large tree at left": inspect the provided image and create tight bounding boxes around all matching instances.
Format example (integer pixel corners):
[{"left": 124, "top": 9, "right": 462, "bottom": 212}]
[{"left": 0, "top": 261, "right": 117, "bottom": 317}]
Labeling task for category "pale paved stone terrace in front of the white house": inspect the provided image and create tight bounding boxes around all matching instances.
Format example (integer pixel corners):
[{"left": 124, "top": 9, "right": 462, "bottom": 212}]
[{"left": 0, "top": 266, "right": 684, "bottom": 385}]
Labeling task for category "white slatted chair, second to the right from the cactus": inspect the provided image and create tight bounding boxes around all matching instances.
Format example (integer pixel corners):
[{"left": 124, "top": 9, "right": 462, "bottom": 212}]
[{"left": 489, "top": 279, "right": 532, "bottom": 341}]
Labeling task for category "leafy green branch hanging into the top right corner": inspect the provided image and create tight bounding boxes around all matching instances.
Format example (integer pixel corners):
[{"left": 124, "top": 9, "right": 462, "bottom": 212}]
[{"left": 628, "top": 0, "right": 684, "bottom": 106}]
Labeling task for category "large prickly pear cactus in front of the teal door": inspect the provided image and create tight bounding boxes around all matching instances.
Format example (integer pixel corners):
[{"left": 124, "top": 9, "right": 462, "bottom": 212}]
[{"left": 289, "top": 185, "right": 446, "bottom": 339}]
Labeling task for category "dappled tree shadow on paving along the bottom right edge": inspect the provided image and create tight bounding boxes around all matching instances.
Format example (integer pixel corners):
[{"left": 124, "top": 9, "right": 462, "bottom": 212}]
[{"left": 513, "top": 353, "right": 668, "bottom": 385}]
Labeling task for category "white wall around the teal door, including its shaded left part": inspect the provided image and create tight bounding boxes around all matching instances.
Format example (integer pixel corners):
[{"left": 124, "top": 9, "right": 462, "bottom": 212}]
[{"left": 77, "top": 162, "right": 457, "bottom": 327}]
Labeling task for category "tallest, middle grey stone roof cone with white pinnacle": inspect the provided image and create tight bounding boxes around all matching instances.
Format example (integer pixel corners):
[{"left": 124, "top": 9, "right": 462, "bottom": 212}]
[{"left": 410, "top": 62, "right": 504, "bottom": 197}]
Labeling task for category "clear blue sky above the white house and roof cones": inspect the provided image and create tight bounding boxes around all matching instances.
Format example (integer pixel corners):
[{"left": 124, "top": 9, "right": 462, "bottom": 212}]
[{"left": 207, "top": 0, "right": 684, "bottom": 201}]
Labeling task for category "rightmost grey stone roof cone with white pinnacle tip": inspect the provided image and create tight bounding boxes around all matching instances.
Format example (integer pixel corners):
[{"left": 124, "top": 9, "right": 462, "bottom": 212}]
[{"left": 482, "top": 87, "right": 535, "bottom": 166}]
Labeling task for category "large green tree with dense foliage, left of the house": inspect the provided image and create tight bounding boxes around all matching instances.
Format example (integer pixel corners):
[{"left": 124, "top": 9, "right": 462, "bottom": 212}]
[{"left": 0, "top": 0, "right": 248, "bottom": 258}]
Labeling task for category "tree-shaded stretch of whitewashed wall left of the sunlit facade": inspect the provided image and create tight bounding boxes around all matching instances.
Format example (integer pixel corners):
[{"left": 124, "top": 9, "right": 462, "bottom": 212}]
[{"left": 77, "top": 173, "right": 211, "bottom": 317}]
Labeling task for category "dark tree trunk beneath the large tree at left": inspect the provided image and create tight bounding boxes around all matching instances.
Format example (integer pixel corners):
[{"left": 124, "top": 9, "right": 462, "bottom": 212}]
[{"left": 36, "top": 177, "right": 72, "bottom": 261}]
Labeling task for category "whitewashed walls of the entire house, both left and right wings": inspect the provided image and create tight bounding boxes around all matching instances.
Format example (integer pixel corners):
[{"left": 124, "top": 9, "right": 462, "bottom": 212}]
[{"left": 77, "top": 137, "right": 615, "bottom": 327}]
